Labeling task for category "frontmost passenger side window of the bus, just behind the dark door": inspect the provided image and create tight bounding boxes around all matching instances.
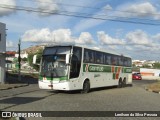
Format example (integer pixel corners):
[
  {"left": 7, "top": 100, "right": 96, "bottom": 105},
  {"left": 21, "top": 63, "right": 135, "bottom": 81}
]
[{"left": 83, "top": 49, "right": 95, "bottom": 63}]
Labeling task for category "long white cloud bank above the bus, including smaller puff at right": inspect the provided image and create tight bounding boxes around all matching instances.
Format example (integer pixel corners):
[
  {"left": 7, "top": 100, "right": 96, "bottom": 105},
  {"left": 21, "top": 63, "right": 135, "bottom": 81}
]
[{"left": 21, "top": 28, "right": 95, "bottom": 44}]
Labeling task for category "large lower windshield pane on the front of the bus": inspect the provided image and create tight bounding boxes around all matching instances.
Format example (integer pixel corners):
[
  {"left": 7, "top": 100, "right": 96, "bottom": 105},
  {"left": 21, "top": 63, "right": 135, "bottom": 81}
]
[{"left": 40, "top": 54, "right": 67, "bottom": 78}]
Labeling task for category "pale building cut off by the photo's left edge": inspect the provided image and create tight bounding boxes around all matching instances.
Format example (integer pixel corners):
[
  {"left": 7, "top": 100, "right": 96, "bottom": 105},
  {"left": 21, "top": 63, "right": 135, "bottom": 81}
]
[{"left": 0, "top": 23, "right": 6, "bottom": 83}]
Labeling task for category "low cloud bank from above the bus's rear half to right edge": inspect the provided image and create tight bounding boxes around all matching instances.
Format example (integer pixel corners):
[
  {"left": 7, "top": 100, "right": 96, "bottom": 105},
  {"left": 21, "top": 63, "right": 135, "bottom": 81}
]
[{"left": 97, "top": 29, "right": 160, "bottom": 59}]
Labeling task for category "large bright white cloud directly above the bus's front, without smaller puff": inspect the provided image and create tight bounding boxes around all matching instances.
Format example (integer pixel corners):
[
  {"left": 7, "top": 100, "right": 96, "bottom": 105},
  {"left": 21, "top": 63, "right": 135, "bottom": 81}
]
[{"left": 22, "top": 28, "right": 73, "bottom": 43}]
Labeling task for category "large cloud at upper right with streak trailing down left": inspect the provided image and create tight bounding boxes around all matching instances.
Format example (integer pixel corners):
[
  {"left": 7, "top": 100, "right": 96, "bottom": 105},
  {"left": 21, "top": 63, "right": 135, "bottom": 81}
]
[{"left": 74, "top": 2, "right": 160, "bottom": 32}]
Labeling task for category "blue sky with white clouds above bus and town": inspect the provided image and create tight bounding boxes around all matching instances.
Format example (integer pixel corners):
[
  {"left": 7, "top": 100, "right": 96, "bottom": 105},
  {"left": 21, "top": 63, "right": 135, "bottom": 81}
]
[{"left": 0, "top": 0, "right": 160, "bottom": 61}]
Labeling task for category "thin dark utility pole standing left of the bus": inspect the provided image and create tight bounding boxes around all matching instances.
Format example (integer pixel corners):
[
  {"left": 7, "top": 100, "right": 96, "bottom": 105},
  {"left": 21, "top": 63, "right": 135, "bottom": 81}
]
[{"left": 18, "top": 39, "right": 21, "bottom": 81}]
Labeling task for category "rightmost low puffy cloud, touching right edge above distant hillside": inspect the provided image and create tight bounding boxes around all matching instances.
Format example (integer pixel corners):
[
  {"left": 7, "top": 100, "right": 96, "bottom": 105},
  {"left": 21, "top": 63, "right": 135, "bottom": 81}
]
[{"left": 125, "top": 30, "right": 160, "bottom": 52}]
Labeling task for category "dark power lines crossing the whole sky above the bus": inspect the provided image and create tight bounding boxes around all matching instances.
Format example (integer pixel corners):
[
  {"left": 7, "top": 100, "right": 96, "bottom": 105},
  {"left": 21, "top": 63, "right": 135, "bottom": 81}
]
[{"left": 0, "top": 4, "right": 160, "bottom": 26}]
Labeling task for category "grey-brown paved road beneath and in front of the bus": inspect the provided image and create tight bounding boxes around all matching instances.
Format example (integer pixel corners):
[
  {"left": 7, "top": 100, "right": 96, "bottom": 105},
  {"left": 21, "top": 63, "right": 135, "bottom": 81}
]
[{"left": 0, "top": 80, "right": 160, "bottom": 119}]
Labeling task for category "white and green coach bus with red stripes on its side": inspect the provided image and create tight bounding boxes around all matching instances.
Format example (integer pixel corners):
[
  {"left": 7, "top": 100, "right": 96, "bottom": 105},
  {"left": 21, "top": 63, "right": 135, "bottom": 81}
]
[{"left": 35, "top": 45, "right": 132, "bottom": 93}]
